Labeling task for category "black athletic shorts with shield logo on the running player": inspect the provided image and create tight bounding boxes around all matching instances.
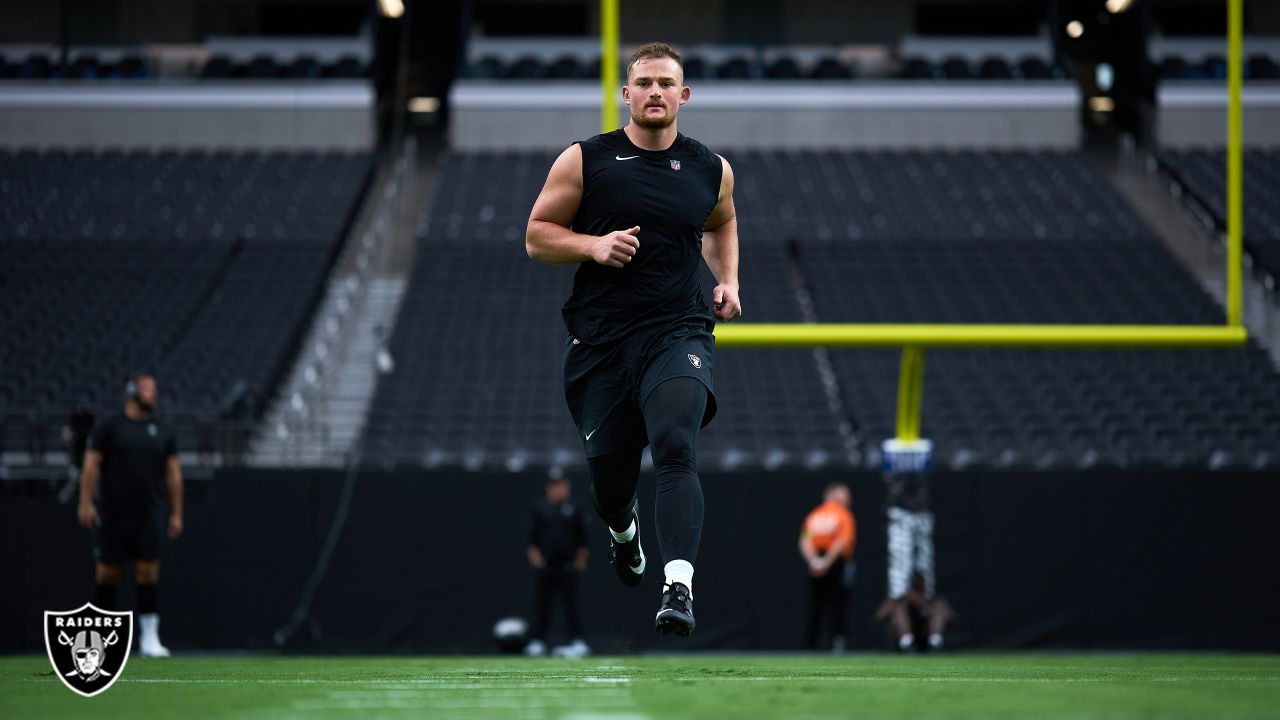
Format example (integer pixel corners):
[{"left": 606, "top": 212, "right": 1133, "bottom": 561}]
[{"left": 564, "top": 319, "right": 716, "bottom": 457}]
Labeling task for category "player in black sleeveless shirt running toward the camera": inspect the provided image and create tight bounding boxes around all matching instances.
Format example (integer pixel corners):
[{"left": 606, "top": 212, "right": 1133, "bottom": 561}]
[{"left": 525, "top": 42, "right": 742, "bottom": 635}]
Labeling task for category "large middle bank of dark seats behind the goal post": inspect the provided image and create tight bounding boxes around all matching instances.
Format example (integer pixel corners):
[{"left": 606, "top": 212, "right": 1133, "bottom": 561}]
[{"left": 365, "top": 149, "right": 1280, "bottom": 469}]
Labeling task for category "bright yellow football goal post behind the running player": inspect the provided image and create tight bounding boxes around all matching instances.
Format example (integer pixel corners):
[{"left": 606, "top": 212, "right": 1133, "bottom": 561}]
[{"left": 600, "top": 0, "right": 1248, "bottom": 453}]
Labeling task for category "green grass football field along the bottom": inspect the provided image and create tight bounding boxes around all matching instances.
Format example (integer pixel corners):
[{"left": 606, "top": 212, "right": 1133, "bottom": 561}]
[{"left": 0, "top": 653, "right": 1280, "bottom": 720}]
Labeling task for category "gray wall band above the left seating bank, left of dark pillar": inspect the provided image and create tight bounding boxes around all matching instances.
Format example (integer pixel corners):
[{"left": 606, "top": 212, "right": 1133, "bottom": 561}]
[{"left": 0, "top": 82, "right": 376, "bottom": 150}]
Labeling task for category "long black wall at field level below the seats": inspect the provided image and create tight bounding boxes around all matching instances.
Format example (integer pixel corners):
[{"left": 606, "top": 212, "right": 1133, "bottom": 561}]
[{"left": 0, "top": 469, "right": 1280, "bottom": 653}]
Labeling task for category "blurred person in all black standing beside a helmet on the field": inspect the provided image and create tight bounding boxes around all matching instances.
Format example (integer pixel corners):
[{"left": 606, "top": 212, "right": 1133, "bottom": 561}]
[{"left": 525, "top": 471, "right": 590, "bottom": 657}]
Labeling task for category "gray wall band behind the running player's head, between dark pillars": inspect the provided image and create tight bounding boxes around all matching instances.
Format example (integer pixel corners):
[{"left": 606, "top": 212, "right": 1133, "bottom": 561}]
[{"left": 449, "top": 81, "right": 1080, "bottom": 149}]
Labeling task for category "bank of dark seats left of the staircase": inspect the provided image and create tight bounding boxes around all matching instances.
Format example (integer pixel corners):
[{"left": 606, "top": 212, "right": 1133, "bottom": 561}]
[{"left": 0, "top": 150, "right": 371, "bottom": 450}]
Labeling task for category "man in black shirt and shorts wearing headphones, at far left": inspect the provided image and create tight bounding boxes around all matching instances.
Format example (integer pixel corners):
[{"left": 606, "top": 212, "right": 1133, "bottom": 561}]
[{"left": 78, "top": 374, "right": 182, "bottom": 657}]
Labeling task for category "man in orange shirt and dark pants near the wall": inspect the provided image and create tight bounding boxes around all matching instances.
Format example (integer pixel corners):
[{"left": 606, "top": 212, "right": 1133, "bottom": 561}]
[{"left": 800, "top": 483, "right": 858, "bottom": 652}]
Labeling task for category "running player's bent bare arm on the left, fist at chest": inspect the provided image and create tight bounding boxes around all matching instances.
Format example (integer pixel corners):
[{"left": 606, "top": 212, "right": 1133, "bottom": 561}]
[{"left": 525, "top": 145, "right": 640, "bottom": 268}]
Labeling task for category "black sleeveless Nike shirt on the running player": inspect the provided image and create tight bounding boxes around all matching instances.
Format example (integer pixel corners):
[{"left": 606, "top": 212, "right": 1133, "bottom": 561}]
[{"left": 562, "top": 129, "right": 723, "bottom": 345}]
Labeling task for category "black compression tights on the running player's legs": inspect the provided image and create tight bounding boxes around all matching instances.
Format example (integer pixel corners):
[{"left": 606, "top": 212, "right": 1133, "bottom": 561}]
[{"left": 588, "top": 378, "right": 707, "bottom": 562}]
